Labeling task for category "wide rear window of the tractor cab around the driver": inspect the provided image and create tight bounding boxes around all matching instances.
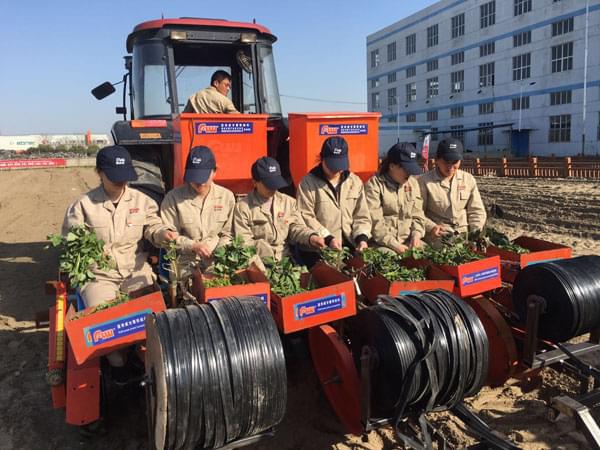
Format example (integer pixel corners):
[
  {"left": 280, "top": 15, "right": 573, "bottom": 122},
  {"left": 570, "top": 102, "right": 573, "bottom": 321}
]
[{"left": 173, "top": 44, "right": 257, "bottom": 114}]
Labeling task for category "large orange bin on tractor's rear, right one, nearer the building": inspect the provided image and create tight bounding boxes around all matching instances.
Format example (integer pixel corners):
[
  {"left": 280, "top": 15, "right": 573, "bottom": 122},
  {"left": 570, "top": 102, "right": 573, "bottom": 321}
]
[{"left": 289, "top": 112, "right": 381, "bottom": 186}]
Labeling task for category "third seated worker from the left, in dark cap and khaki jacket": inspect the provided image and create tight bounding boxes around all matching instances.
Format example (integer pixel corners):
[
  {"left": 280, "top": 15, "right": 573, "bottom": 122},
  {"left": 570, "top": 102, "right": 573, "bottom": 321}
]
[{"left": 233, "top": 157, "right": 325, "bottom": 260}]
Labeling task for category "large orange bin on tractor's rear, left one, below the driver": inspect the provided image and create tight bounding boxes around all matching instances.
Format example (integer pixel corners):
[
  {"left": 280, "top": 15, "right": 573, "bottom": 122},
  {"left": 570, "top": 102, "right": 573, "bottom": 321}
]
[{"left": 173, "top": 113, "right": 268, "bottom": 194}]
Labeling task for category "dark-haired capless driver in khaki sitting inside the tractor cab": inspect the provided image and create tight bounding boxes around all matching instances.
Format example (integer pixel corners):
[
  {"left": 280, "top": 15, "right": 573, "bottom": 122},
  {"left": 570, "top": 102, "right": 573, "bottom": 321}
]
[{"left": 183, "top": 70, "right": 238, "bottom": 114}]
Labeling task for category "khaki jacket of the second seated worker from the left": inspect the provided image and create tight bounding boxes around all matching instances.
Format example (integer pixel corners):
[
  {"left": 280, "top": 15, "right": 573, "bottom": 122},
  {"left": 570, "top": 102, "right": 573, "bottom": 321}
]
[{"left": 160, "top": 183, "right": 235, "bottom": 262}]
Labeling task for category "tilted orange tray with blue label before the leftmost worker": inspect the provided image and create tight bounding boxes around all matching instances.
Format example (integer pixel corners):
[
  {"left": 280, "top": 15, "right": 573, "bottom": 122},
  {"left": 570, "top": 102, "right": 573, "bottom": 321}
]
[{"left": 65, "top": 291, "right": 165, "bottom": 365}]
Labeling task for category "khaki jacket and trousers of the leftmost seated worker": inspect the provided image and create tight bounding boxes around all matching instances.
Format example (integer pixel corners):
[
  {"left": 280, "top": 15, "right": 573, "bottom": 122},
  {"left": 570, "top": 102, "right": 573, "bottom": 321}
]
[{"left": 62, "top": 186, "right": 166, "bottom": 307}]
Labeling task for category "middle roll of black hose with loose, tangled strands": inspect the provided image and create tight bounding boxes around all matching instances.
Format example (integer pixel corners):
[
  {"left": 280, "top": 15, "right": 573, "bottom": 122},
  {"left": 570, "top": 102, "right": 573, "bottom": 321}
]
[{"left": 349, "top": 290, "right": 489, "bottom": 425}]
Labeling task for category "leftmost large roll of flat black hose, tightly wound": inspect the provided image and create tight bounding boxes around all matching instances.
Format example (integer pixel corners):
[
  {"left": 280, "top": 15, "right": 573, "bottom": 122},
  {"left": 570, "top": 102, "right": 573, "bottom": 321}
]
[{"left": 147, "top": 297, "right": 287, "bottom": 449}]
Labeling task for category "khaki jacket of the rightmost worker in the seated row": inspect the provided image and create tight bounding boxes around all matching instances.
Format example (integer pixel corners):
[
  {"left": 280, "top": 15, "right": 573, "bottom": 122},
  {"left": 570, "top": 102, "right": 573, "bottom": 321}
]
[{"left": 419, "top": 169, "right": 487, "bottom": 240}]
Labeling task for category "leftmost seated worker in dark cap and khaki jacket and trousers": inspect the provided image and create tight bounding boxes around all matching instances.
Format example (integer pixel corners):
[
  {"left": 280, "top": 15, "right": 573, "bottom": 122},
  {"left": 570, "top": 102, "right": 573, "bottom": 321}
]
[{"left": 62, "top": 145, "right": 177, "bottom": 367}]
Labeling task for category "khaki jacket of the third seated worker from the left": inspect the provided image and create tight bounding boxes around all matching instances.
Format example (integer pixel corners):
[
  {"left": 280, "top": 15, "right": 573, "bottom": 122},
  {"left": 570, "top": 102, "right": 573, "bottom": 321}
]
[{"left": 233, "top": 191, "right": 317, "bottom": 260}]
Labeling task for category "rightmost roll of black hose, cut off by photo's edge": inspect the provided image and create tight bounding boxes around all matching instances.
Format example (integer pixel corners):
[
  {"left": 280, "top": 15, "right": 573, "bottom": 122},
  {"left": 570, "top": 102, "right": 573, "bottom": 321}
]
[{"left": 513, "top": 256, "right": 600, "bottom": 342}]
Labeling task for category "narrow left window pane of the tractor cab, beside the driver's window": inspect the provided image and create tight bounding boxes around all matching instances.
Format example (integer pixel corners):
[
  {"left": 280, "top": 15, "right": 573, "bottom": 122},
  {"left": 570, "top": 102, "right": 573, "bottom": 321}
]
[{"left": 132, "top": 42, "right": 171, "bottom": 118}]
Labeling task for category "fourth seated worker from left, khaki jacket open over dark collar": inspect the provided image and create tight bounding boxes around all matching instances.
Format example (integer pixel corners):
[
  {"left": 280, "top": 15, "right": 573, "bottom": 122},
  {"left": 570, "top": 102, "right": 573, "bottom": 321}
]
[{"left": 296, "top": 136, "right": 371, "bottom": 267}]
